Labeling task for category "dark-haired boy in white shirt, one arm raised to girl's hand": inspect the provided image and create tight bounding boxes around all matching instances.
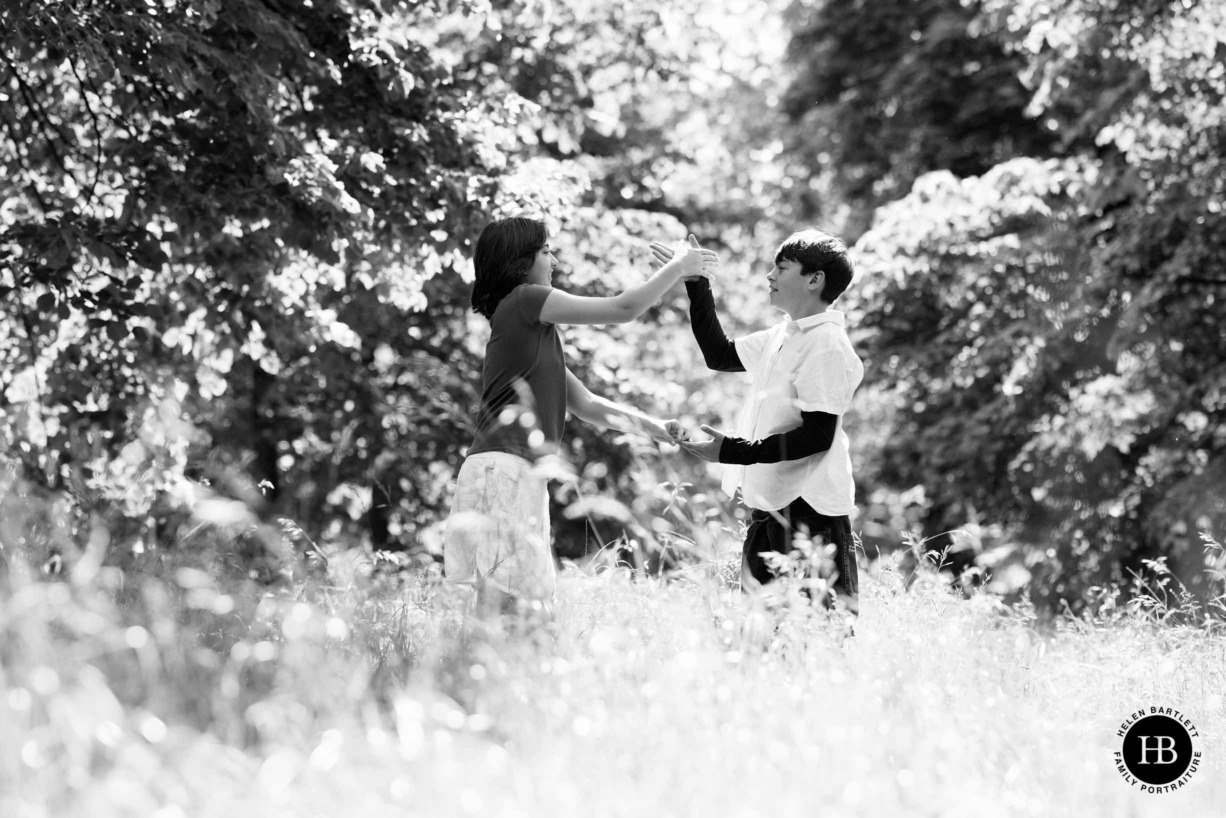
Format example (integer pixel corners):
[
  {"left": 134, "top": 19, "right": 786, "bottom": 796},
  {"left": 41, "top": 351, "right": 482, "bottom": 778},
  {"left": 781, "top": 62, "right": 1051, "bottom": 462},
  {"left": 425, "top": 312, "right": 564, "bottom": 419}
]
[{"left": 651, "top": 229, "right": 864, "bottom": 612}]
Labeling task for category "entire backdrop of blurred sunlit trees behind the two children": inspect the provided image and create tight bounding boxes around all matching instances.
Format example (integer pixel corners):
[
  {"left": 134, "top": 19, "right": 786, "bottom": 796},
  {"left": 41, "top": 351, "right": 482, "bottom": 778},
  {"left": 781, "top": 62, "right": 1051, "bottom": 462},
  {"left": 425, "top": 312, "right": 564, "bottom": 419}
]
[{"left": 0, "top": 0, "right": 1226, "bottom": 605}]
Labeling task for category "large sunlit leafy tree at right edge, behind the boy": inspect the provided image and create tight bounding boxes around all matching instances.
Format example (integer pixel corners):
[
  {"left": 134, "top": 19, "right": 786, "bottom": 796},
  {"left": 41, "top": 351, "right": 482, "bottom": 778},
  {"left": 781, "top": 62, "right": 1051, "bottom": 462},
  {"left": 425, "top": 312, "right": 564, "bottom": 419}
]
[{"left": 859, "top": 2, "right": 1226, "bottom": 608}]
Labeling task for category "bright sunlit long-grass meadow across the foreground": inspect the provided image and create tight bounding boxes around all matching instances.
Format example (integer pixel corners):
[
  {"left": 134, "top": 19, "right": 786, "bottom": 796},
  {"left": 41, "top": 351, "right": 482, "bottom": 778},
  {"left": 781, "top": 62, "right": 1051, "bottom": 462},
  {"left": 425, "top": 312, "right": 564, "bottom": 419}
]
[{"left": 0, "top": 532, "right": 1226, "bottom": 818}]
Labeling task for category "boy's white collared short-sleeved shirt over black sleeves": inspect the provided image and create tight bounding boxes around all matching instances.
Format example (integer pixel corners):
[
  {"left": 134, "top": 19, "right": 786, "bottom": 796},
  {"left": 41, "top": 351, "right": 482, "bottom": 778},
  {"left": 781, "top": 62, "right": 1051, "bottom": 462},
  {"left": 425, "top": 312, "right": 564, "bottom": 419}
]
[{"left": 721, "top": 309, "right": 864, "bottom": 516}]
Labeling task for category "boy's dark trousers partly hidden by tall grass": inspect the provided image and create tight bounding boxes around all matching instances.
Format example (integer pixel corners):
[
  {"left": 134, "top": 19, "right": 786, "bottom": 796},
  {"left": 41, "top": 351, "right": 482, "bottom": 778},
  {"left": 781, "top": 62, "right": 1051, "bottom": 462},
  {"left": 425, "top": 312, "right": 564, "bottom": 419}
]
[{"left": 741, "top": 497, "right": 859, "bottom": 612}]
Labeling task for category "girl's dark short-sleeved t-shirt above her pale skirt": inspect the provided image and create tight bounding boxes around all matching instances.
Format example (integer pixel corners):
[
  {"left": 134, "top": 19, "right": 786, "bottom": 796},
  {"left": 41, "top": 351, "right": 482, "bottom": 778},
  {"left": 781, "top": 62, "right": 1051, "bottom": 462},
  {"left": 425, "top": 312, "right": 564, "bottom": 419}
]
[{"left": 468, "top": 285, "right": 566, "bottom": 460}]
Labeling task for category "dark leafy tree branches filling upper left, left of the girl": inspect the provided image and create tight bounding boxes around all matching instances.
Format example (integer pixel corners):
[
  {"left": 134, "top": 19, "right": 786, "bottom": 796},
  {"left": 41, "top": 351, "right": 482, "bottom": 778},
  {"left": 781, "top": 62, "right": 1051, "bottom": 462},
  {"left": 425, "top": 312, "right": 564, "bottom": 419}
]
[{"left": 2, "top": 0, "right": 509, "bottom": 549}]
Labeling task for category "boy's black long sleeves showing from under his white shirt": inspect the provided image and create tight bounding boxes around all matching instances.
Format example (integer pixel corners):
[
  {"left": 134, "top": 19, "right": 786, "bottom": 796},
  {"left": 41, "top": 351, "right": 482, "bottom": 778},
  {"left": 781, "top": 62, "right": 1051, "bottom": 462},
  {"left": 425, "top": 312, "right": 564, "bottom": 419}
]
[{"left": 685, "top": 278, "right": 839, "bottom": 466}]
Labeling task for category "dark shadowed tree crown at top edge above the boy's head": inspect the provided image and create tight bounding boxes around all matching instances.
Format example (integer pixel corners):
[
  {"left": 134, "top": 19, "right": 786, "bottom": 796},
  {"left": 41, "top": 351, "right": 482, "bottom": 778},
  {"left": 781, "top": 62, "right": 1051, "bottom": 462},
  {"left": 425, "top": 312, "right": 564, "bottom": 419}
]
[{"left": 782, "top": 0, "right": 1056, "bottom": 235}]
